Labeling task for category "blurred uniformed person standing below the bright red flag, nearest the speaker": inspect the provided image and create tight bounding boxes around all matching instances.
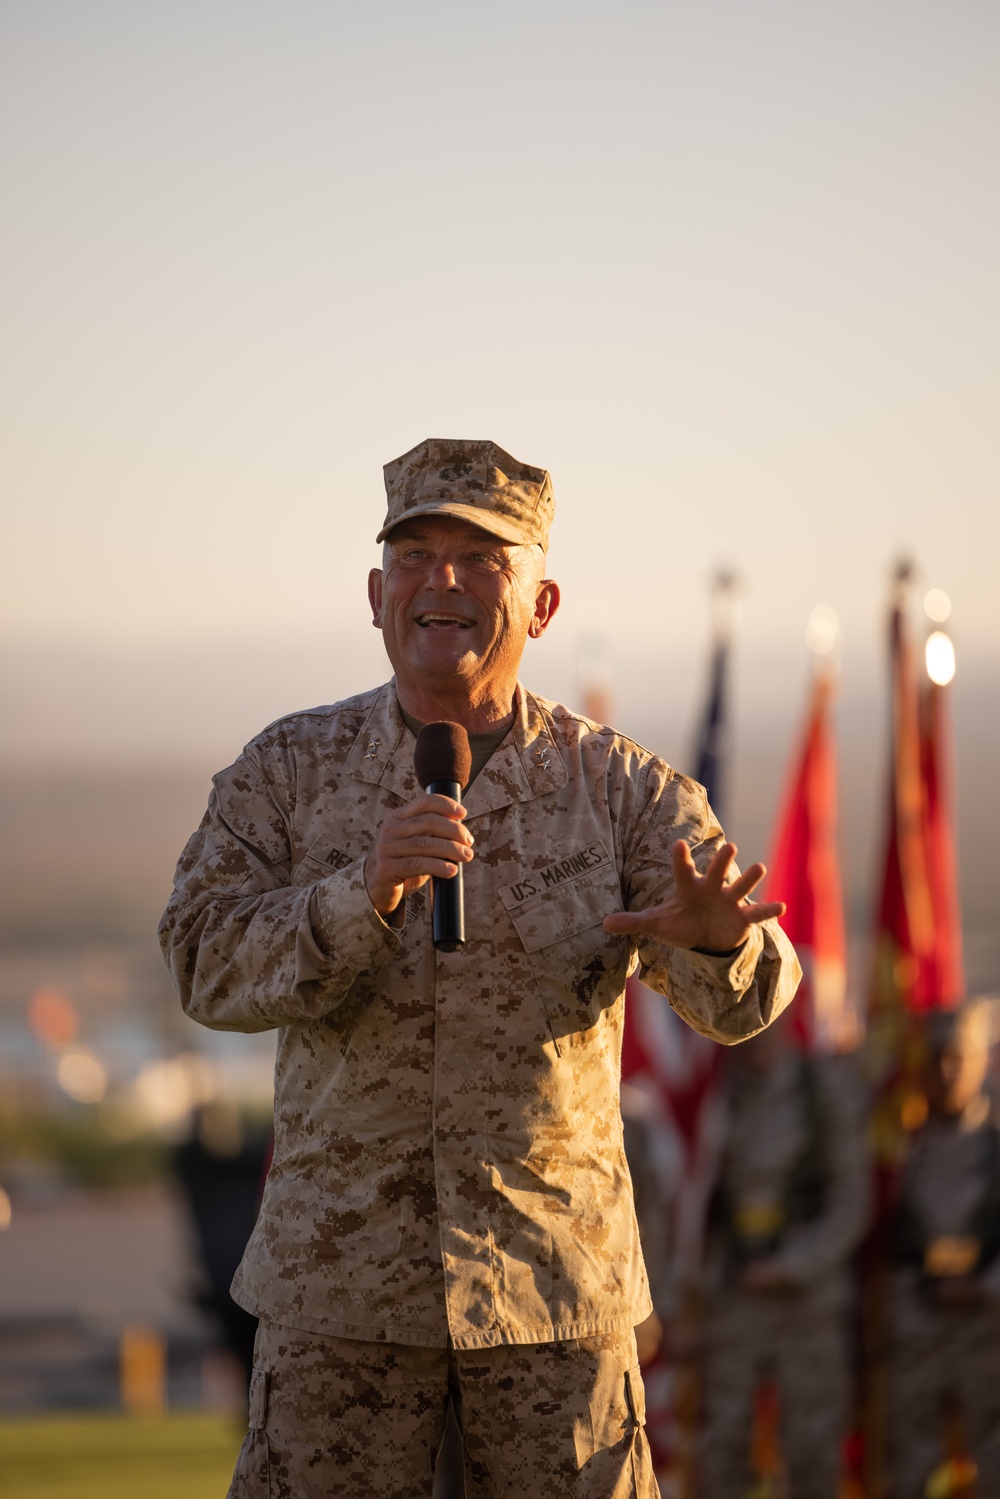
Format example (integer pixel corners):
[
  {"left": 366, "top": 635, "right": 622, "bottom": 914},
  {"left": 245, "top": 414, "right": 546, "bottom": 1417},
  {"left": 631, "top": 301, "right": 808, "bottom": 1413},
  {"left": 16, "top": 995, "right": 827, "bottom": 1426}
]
[{"left": 702, "top": 1022, "right": 870, "bottom": 1499}]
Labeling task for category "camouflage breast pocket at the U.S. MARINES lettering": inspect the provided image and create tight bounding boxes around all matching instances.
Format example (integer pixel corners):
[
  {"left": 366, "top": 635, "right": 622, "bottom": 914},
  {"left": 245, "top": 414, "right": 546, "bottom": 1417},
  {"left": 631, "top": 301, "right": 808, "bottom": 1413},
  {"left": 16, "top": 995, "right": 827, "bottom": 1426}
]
[{"left": 508, "top": 863, "right": 631, "bottom": 1051}]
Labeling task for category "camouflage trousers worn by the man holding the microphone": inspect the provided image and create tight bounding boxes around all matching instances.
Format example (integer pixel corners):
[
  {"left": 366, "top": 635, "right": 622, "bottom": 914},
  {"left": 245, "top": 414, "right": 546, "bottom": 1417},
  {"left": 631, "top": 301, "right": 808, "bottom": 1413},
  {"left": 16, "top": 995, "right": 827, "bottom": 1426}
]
[{"left": 229, "top": 1322, "right": 658, "bottom": 1499}]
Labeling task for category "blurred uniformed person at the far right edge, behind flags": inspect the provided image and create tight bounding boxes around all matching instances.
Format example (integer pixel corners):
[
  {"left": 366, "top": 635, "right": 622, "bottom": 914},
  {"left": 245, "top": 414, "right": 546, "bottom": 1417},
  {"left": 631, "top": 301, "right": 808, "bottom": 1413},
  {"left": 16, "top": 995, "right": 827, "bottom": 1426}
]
[{"left": 889, "top": 1001, "right": 1000, "bottom": 1499}]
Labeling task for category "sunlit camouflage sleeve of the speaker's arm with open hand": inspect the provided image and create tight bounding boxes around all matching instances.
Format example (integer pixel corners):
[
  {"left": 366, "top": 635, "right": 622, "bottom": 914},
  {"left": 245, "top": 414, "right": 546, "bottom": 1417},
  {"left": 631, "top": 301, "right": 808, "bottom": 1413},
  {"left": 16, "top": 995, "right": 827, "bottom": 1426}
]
[{"left": 622, "top": 760, "right": 802, "bottom": 1046}]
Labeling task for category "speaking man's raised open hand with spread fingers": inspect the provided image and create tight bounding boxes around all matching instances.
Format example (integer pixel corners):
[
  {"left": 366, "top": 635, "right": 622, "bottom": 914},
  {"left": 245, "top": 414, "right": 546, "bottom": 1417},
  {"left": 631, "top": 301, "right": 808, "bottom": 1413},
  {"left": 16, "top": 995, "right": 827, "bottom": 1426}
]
[{"left": 604, "top": 838, "right": 786, "bottom": 953}]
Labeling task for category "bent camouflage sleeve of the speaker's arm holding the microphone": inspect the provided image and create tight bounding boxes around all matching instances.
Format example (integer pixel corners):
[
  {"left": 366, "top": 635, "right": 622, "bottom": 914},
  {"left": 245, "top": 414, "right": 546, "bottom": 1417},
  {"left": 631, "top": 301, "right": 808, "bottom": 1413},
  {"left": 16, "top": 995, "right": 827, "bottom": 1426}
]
[{"left": 159, "top": 748, "right": 400, "bottom": 1031}]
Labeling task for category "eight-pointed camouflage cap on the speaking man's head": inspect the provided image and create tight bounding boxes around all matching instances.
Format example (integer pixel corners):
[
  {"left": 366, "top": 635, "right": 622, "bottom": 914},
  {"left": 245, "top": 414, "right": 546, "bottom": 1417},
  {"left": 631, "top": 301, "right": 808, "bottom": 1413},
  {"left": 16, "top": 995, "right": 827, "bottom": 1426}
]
[{"left": 375, "top": 438, "right": 555, "bottom": 552}]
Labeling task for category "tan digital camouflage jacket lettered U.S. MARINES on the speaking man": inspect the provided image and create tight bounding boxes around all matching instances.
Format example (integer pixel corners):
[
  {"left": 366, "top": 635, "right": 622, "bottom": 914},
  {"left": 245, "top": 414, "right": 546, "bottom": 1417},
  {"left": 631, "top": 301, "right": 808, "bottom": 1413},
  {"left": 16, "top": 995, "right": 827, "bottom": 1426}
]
[{"left": 160, "top": 684, "right": 798, "bottom": 1499}]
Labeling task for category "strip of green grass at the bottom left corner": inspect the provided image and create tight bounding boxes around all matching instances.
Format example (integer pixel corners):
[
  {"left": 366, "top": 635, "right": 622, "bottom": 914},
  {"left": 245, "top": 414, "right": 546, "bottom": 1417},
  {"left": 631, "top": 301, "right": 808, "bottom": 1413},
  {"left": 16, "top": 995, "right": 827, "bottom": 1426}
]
[{"left": 0, "top": 1415, "right": 241, "bottom": 1499}]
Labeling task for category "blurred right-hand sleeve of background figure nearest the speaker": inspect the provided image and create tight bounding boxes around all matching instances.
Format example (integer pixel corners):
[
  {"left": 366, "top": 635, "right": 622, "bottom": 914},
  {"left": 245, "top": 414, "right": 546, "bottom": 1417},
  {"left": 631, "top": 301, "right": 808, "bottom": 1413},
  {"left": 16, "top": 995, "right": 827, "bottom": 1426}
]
[{"left": 775, "top": 1057, "right": 871, "bottom": 1285}]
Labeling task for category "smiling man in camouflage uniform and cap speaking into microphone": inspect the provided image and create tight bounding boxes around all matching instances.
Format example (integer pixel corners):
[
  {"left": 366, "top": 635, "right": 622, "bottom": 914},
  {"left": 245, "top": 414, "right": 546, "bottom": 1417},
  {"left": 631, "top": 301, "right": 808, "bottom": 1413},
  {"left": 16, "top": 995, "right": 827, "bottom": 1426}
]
[{"left": 160, "top": 439, "right": 799, "bottom": 1499}]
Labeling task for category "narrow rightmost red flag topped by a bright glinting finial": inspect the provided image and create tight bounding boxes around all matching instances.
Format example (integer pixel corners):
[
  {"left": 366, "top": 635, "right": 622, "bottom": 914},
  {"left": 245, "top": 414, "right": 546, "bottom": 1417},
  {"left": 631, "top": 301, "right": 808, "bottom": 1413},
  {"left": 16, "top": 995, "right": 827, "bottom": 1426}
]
[{"left": 921, "top": 630, "right": 966, "bottom": 1009}]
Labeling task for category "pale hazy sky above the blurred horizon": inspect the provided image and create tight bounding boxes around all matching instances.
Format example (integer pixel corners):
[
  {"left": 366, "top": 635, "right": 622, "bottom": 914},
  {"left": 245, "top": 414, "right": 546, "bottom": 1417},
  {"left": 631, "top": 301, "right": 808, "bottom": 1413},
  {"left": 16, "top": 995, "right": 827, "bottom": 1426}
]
[{"left": 0, "top": 0, "right": 1000, "bottom": 751}]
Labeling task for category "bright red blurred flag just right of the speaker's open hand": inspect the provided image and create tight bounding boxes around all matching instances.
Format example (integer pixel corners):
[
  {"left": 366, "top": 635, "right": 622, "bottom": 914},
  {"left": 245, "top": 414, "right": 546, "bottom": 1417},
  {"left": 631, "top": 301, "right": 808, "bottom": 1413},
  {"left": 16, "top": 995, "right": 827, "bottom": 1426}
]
[{"left": 768, "top": 670, "right": 855, "bottom": 1051}]
